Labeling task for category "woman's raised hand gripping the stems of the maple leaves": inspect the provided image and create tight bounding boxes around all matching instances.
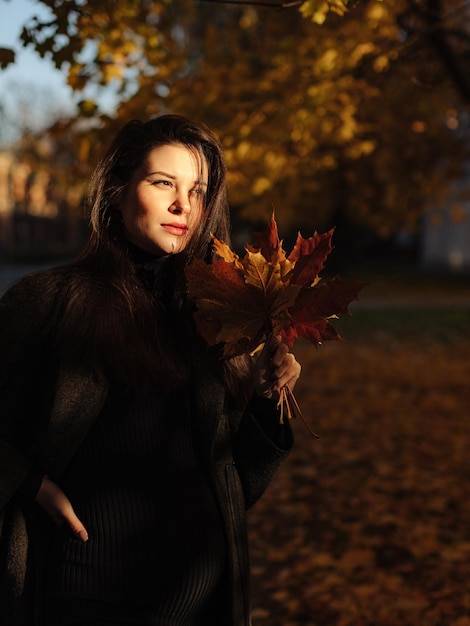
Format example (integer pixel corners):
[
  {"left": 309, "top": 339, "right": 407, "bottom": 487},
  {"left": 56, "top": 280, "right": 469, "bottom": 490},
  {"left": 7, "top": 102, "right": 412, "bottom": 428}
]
[{"left": 255, "top": 335, "right": 301, "bottom": 400}]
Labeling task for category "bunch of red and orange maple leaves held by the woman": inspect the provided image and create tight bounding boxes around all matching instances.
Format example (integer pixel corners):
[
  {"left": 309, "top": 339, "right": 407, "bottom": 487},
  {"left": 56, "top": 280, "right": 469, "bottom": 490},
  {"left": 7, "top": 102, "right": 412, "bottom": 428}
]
[{"left": 185, "top": 216, "right": 364, "bottom": 434}]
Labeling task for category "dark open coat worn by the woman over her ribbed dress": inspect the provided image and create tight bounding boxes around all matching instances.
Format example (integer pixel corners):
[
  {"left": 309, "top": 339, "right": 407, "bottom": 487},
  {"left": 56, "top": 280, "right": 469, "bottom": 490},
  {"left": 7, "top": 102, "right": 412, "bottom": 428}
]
[{"left": 0, "top": 271, "right": 292, "bottom": 626}]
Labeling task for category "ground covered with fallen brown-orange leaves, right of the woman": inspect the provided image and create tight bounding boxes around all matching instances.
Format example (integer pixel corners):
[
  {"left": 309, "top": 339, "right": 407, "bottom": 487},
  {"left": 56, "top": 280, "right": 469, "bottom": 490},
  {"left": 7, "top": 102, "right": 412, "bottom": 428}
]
[{"left": 249, "top": 300, "right": 470, "bottom": 626}]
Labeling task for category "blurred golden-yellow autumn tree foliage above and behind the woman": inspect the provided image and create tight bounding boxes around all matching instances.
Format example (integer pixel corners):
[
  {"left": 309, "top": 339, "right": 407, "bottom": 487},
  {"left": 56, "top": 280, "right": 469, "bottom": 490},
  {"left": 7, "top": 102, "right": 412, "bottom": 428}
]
[{"left": 0, "top": 0, "right": 470, "bottom": 236}]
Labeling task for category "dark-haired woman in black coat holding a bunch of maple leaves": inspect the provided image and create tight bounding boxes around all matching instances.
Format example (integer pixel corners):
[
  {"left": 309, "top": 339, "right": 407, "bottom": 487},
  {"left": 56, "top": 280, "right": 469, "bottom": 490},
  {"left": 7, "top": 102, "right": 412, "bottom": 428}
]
[{"left": 0, "top": 115, "right": 300, "bottom": 626}]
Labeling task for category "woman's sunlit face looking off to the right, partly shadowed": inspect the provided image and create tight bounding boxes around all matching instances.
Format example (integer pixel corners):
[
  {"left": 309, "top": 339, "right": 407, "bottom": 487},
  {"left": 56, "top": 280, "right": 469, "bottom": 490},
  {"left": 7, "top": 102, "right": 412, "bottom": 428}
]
[{"left": 118, "top": 143, "right": 208, "bottom": 256}]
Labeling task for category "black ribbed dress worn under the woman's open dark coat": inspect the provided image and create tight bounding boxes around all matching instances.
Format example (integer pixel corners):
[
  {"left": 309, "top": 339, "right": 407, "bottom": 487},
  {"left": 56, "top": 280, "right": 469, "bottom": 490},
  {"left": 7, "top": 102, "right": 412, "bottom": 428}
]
[{"left": 43, "top": 388, "right": 225, "bottom": 626}]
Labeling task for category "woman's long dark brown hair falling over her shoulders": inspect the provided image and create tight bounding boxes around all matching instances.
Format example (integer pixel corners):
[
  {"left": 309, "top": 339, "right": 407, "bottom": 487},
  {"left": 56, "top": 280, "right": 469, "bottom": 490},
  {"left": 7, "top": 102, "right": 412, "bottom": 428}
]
[{"left": 58, "top": 115, "right": 249, "bottom": 395}]
